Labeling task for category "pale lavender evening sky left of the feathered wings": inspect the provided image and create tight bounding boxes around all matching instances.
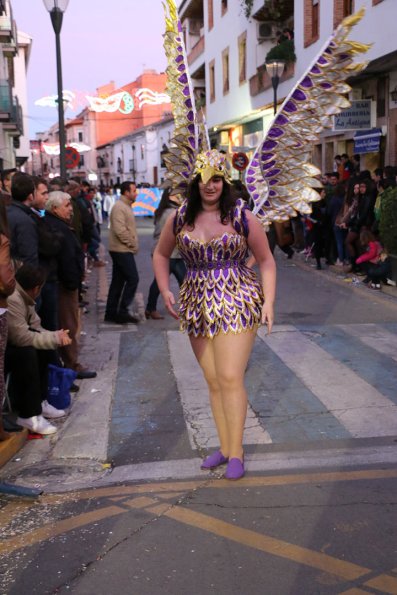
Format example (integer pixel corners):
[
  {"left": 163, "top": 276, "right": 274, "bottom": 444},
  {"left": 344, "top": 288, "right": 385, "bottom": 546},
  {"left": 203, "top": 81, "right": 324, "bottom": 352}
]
[{"left": 11, "top": 0, "right": 166, "bottom": 138}]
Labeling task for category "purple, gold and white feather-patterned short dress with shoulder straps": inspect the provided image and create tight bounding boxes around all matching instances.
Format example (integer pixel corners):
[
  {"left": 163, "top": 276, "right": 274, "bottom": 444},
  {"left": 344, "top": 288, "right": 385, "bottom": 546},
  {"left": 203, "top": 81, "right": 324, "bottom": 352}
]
[{"left": 174, "top": 199, "right": 263, "bottom": 338}]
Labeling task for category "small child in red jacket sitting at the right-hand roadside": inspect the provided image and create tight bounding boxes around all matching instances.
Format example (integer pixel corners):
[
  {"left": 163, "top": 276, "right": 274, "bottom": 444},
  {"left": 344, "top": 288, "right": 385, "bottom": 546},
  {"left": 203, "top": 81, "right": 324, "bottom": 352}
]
[{"left": 356, "top": 230, "right": 391, "bottom": 289}]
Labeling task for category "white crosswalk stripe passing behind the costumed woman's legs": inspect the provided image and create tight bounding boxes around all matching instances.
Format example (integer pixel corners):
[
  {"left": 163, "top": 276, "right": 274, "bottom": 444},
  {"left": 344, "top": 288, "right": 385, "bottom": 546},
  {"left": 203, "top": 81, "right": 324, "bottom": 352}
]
[{"left": 167, "top": 331, "right": 272, "bottom": 449}]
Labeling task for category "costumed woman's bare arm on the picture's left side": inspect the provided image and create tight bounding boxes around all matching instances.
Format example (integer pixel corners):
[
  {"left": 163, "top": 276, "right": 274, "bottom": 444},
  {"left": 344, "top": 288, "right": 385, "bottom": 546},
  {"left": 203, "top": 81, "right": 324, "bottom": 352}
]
[{"left": 153, "top": 213, "right": 179, "bottom": 319}]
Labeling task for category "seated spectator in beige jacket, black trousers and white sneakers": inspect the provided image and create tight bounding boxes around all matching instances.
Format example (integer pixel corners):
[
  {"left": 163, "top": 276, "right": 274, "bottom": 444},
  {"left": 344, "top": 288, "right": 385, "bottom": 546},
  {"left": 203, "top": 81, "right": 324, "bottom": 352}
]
[{"left": 5, "top": 264, "right": 70, "bottom": 434}]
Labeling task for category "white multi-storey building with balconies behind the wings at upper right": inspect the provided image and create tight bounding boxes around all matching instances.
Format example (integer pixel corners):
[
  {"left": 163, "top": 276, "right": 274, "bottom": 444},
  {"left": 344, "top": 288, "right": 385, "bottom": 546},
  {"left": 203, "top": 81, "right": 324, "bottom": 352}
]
[{"left": 179, "top": 0, "right": 397, "bottom": 171}]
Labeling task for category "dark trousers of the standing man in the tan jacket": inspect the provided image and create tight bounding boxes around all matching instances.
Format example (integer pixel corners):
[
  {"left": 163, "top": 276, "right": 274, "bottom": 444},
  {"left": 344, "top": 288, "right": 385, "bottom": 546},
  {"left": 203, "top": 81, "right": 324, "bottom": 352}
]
[{"left": 105, "top": 252, "right": 139, "bottom": 318}]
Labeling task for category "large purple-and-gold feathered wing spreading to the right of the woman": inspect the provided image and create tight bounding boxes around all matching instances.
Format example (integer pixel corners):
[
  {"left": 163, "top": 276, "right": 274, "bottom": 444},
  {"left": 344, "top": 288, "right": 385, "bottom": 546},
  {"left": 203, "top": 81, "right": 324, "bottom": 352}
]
[{"left": 246, "top": 9, "right": 371, "bottom": 225}]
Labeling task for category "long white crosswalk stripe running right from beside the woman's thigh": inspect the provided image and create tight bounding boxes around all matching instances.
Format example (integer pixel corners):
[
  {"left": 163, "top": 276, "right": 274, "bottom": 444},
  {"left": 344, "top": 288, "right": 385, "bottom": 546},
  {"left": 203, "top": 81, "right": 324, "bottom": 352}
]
[{"left": 258, "top": 325, "right": 397, "bottom": 438}]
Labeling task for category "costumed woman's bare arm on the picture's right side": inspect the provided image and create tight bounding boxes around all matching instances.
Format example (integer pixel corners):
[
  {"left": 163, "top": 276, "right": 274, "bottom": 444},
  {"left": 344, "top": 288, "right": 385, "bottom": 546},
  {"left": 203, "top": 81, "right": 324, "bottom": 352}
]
[{"left": 246, "top": 211, "right": 276, "bottom": 333}]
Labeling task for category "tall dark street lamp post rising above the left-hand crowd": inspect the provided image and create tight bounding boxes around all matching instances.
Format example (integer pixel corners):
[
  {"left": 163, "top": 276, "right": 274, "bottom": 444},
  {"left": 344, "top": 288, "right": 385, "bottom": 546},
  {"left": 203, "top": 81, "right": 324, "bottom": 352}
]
[{"left": 43, "top": 0, "right": 69, "bottom": 180}]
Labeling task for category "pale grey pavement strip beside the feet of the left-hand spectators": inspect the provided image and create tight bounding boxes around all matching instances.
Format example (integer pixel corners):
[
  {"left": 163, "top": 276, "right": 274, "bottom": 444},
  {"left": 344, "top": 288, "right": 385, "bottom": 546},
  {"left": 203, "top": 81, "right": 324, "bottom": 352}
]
[{"left": 0, "top": 254, "right": 120, "bottom": 483}]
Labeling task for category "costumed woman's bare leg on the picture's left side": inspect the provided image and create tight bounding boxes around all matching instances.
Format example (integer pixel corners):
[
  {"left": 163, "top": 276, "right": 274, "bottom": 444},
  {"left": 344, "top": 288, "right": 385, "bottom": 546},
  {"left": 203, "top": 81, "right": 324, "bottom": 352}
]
[{"left": 189, "top": 337, "right": 229, "bottom": 457}]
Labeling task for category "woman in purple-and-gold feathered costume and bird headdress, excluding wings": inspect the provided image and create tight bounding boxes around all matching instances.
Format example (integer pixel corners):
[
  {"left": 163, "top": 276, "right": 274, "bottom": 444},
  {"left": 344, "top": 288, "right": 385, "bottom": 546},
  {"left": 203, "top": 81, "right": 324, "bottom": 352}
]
[{"left": 153, "top": 150, "right": 276, "bottom": 479}]
